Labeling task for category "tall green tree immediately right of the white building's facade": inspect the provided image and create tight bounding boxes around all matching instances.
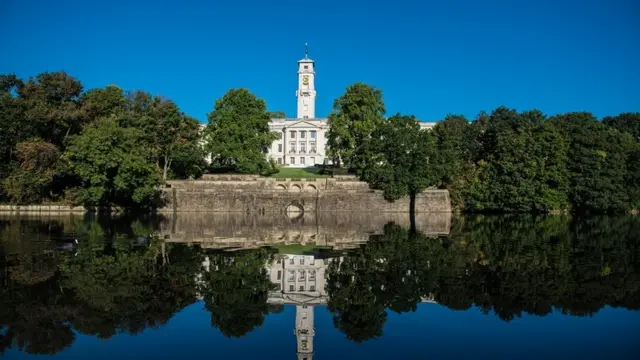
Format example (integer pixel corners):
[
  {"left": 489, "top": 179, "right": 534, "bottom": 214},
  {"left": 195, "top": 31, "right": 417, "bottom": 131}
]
[{"left": 327, "top": 83, "right": 386, "bottom": 171}]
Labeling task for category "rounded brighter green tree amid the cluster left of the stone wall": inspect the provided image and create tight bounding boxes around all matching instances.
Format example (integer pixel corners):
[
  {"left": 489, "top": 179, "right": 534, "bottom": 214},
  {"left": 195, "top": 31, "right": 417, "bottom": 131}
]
[{"left": 66, "top": 119, "right": 160, "bottom": 207}]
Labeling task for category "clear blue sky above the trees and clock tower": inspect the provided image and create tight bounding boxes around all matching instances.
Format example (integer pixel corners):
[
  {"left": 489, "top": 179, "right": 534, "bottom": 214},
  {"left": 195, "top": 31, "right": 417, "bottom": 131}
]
[{"left": 0, "top": 0, "right": 640, "bottom": 121}]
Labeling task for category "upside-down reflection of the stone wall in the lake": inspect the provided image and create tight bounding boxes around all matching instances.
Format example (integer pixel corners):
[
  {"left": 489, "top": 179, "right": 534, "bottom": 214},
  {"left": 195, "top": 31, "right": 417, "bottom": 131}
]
[{"left": 158, "top": 212, "right": 451, "bottom": 249}]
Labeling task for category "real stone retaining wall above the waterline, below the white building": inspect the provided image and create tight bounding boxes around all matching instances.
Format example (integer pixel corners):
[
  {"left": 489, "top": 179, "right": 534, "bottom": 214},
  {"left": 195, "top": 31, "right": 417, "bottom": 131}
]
[{"left": 160, "top": 175, "right": 451, "bottom": 213}]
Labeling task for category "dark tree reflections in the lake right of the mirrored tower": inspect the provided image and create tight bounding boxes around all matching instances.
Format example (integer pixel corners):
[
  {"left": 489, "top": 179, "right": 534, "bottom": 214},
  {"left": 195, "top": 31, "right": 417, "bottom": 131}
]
[{"left": 327, "top": 216, "right": 640, "bottom": 342}]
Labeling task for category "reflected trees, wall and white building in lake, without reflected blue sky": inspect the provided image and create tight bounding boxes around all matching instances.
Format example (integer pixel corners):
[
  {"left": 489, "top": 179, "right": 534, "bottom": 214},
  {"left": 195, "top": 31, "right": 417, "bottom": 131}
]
[{"left": 0, "top": 214, "right": 640, "bottom": 359}]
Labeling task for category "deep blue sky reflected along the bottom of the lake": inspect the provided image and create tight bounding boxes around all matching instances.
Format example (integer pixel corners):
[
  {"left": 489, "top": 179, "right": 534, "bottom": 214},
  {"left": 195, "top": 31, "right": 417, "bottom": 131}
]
[{"left": 5, "top": 303, "right": 640, "bottom": 360}]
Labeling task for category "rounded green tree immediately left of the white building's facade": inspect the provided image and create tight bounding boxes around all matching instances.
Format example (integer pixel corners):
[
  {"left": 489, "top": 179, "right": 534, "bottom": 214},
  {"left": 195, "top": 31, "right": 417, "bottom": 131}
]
[{"left": 206, "top": 89, "right": 276, "bottom": 174}]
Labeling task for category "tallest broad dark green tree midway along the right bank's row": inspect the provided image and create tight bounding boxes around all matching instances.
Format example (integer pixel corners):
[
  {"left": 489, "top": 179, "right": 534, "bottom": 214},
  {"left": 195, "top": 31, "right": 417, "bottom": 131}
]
[{"left": 468, "top": 107, "right": 568, "bottom": 212}]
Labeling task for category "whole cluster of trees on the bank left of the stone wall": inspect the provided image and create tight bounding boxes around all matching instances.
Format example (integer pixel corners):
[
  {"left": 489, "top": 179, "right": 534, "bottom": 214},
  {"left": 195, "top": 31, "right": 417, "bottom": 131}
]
[{"left": 0, "top": 72, "right": 206, "bottom": 207}]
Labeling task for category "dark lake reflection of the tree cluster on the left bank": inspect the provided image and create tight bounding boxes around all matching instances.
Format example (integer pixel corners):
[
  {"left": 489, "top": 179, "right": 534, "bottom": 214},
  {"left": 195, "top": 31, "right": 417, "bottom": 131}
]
[{"left": 0, "top": 217, "right": 200, "bottom": 354}]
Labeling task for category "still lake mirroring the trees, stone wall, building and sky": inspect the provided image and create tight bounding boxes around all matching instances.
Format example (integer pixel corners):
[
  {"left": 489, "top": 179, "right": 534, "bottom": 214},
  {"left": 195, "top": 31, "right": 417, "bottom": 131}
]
[{"left": 0, "top": 214, "right": 640, "bottom": 360}]
